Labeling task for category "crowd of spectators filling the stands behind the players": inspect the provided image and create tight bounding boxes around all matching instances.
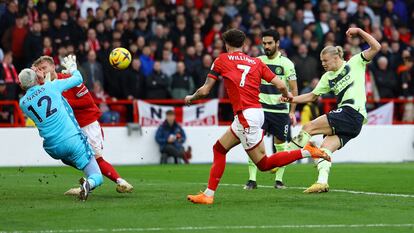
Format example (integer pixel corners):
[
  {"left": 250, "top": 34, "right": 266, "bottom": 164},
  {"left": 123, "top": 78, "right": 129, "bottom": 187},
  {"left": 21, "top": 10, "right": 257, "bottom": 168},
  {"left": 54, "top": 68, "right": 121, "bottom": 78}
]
[{"left": 0, "top": 0, "right": 414, "bottom": 123}]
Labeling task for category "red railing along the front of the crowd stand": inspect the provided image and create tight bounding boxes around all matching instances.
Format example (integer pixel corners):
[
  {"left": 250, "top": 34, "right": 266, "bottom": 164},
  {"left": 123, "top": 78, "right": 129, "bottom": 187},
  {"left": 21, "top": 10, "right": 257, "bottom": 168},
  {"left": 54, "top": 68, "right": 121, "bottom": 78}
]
[{"left": 0, "top": 99, "right": 414, "bottom": 127}]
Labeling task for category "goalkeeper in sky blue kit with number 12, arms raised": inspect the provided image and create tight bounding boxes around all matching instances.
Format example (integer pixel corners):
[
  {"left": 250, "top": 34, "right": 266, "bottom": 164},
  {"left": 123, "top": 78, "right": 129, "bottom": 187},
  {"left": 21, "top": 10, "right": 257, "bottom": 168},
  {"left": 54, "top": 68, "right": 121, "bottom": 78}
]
[{"left": 19, "top": 55, "right": 103, "bottom": 200}]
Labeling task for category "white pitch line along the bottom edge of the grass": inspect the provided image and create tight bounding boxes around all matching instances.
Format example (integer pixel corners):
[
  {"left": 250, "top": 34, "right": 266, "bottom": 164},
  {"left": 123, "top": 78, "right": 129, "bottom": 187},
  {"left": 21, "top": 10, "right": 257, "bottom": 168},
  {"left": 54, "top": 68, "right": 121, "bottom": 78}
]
[{"left": 0, "top": 223, "right": 414, "bottom": 233}]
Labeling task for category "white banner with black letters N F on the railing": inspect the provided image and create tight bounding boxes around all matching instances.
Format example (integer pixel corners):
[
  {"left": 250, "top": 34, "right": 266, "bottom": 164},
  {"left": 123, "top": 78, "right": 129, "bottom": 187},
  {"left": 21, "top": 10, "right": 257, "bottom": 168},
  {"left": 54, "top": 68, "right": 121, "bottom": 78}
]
[{"left": 137, "top": 99, "right": 219, "bottom": 126}]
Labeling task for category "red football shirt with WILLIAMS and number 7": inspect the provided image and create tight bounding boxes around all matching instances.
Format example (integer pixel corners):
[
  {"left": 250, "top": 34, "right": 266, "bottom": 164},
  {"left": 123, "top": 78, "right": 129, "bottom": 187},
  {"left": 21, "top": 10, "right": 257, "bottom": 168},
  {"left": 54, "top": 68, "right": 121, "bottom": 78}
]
[{"left": 207, "top": 52, "right": 276, "bottom": 114}]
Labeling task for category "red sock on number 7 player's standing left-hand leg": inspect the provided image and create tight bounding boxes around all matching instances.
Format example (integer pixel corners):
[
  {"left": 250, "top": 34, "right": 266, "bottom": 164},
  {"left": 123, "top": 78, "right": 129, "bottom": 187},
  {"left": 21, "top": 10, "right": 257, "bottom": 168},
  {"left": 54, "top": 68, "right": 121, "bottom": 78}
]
[{"left": 207, "top": 141, "right": 227, "bottom": 191}]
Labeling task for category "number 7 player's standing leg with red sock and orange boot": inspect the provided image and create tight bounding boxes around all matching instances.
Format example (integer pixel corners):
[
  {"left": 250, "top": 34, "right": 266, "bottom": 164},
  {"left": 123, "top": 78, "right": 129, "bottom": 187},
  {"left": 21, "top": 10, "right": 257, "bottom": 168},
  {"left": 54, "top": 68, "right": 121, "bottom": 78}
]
[{"left": 187, "top": 128, "right": 240, "bottom": 204}]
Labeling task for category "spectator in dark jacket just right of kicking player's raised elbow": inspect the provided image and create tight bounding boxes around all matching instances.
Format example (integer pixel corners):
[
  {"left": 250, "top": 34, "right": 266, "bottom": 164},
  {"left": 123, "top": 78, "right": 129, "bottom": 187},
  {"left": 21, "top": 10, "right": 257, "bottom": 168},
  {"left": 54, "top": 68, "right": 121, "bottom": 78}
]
[{"left": 373, "top": 57, "right": 398, "bottom": 98}]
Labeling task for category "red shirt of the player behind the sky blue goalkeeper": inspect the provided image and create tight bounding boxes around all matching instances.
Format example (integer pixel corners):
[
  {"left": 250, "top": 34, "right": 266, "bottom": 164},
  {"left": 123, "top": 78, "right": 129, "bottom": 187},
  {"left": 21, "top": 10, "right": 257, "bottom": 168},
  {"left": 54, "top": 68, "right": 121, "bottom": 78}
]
[{"left": 58, "top": 73, "right": 101, "bottom": 128}]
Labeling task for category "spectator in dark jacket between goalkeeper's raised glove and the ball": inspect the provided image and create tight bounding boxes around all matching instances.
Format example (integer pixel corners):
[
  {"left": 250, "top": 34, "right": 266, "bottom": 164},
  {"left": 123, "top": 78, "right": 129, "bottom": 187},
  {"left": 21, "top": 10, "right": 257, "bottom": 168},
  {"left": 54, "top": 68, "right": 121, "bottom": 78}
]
[{"left": 82, "top": 50, "right": 104, "bottom": 90}]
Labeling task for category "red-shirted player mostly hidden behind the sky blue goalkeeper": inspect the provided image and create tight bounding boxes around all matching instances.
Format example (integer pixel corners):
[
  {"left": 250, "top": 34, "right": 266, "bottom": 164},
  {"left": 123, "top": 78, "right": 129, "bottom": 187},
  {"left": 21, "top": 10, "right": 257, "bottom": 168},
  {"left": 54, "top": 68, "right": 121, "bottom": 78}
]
[{"left": 32, "top": 56, "right": 134, "bottom": 195}]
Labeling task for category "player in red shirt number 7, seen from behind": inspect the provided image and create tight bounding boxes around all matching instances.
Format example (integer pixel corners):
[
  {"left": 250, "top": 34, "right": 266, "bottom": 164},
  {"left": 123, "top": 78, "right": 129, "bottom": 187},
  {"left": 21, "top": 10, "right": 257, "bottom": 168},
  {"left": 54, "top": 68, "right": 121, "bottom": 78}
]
[{"left": 184, "top": 29, "right": 330, "bottom": 204}]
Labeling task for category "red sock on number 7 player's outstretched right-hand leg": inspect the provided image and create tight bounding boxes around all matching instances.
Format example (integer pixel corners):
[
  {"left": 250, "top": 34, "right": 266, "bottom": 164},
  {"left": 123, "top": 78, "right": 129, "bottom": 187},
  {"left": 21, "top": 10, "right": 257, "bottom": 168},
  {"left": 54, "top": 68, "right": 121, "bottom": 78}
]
[{"left": 256, "top": 150, "right": 303, "bottom": 171}]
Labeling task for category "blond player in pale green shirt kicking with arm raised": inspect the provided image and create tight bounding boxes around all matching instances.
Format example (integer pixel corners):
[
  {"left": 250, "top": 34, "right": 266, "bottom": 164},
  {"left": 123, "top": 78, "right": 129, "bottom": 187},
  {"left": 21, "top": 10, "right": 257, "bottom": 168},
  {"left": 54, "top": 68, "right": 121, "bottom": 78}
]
[{"left": 288, "top": 28, "right": 381, "bottom": 193}]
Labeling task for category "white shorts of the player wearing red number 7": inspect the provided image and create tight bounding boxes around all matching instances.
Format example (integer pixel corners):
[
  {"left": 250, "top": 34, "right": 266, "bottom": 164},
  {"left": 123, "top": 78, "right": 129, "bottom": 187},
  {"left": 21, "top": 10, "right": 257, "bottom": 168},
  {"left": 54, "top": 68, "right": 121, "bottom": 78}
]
[{"left": 230, "top": 108, "right": 264, "bottom": 151}]
